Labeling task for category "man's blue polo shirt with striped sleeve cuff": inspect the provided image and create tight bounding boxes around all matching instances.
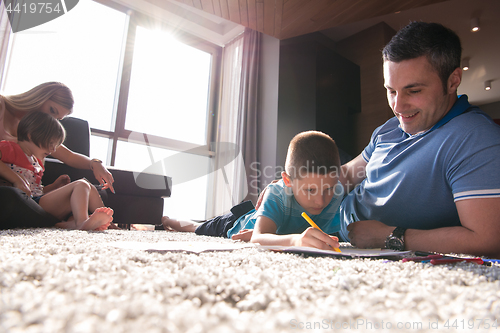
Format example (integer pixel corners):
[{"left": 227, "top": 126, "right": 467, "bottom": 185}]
[{"left": 340, "top": 95, "right": 500, "bottom": 240}]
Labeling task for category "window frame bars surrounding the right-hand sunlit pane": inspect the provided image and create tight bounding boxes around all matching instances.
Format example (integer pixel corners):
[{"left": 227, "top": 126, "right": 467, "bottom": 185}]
[{"left": 90, "top": 0, "right": 223, "bottom": 166}]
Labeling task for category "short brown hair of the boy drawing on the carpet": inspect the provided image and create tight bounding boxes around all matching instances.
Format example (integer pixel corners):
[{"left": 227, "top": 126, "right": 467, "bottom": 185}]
[{"left": 285, "top": 131, "right": 340, "bottom": 179}]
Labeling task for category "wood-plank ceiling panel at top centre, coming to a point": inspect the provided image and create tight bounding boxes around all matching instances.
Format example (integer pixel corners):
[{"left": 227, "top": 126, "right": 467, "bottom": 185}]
[{"left": 170, "top": 0, "right": 445, "bottom": 39}]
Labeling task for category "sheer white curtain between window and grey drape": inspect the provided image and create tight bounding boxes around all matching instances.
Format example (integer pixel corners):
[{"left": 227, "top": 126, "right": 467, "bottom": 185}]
[{"left": 207, "top": 29, "right": 260, "bottom": 217}]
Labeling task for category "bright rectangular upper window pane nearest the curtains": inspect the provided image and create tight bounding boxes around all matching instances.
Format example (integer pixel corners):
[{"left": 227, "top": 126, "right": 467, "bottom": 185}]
[{"left": 125, "top": 26, "right": 211, "bottom": 145}]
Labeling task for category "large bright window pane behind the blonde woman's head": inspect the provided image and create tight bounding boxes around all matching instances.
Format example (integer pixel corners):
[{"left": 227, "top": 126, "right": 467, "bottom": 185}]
[{"left": 3, "top": 0, "right": 127, "bottom": 130}]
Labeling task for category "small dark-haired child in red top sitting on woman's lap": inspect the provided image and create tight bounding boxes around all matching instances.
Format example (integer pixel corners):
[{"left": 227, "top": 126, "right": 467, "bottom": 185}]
[{"left": 0, "top": 111, "right": 113, "bottom": 230}]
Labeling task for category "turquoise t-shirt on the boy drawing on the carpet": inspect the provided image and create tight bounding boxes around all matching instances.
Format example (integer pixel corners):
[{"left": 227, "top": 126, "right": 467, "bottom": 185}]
[{"left": 227, "top": 180, "right": 344, "bottom": 238}]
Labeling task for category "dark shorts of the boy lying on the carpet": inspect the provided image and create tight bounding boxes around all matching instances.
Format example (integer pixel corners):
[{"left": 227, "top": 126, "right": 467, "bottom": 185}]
[{"left": 195, "top": 201, "right": 254, "bottom": 238}]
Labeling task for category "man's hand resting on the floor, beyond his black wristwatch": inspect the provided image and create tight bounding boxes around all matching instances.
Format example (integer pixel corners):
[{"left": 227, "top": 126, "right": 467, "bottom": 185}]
[{"left": 347, "top": 220, "right": 395, "bottom": 249}]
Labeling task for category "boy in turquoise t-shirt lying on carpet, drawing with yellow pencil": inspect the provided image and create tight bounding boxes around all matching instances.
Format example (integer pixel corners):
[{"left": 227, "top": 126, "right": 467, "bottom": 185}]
[{"left": 162, "top": 131, "right": 343, "bottom": 250}]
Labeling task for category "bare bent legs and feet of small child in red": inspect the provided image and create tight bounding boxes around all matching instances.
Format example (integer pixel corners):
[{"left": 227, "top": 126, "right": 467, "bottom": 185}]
[{"left": 40, "top": 180, "right": 113, "bottom": 230}]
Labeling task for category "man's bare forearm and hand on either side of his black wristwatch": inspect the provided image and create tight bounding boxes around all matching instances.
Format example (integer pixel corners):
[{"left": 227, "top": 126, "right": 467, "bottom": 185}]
[{"left": 347, "top": 198, "right": 500, "bottom": 257}]
